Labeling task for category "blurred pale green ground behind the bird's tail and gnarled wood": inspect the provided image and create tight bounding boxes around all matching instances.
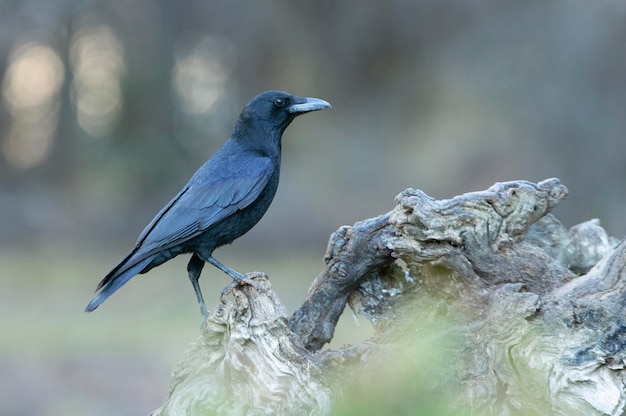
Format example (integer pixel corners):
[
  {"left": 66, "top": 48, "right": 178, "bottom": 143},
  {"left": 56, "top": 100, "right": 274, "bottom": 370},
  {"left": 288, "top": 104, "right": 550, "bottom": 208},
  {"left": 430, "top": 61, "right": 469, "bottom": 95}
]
[{"left": 0, "top": 245, "right": 372, "bottom": 416}]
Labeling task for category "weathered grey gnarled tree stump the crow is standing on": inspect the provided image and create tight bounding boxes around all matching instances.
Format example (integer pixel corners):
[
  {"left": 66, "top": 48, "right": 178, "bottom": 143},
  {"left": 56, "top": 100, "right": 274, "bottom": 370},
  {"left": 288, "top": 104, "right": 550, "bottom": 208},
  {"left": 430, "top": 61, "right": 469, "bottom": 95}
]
[{"left": 153, "top": 179, "right": 626, "bottom": 415}]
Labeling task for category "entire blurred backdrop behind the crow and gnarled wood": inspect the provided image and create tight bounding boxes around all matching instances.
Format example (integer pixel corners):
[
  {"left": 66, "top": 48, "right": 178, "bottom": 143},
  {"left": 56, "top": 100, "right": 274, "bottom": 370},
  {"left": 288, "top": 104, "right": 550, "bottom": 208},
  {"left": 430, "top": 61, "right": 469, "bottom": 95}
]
[{"left": 0, "top": 0, "right": 626, "bottom": 415}]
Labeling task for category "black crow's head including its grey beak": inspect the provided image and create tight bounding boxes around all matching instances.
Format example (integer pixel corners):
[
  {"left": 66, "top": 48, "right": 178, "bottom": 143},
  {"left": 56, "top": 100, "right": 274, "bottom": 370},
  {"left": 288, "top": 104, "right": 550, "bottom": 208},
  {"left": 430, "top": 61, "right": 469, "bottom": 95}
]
[{"left": 233, "top": 91, "right": 331, "bottom": 140}]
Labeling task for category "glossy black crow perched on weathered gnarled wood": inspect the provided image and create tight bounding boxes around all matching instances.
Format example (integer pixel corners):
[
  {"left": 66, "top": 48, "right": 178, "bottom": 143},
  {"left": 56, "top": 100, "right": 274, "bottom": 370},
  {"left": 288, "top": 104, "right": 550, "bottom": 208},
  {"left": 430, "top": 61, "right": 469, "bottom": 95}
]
[{"left": 85, "top": 91, "right": 330, "bottom": 316}]
